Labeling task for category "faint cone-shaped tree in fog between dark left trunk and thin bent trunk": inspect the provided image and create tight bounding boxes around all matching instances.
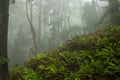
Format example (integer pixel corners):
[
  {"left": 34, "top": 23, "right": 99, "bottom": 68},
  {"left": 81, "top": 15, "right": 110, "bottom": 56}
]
[{"left": 10, "top": 25, "right": 31, "bottom": 66}]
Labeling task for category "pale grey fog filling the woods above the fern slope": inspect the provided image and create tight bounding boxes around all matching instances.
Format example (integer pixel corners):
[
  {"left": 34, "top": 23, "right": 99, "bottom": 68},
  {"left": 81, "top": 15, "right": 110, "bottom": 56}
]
[{"left": 8, "top": 0, "right": 108, "bottom": 67}]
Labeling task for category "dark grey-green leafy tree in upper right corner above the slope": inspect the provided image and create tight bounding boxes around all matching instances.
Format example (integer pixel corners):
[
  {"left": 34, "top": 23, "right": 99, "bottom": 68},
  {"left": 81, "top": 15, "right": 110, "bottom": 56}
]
[{"left": 100, "top": 0, "right": 120, "bottom": 25}]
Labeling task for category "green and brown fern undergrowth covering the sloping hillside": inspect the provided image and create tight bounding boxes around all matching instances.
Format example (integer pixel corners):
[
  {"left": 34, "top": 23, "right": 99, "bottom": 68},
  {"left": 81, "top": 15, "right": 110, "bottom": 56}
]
[{"left": 10, "top": 26, "right": 120, "bottom": 80}]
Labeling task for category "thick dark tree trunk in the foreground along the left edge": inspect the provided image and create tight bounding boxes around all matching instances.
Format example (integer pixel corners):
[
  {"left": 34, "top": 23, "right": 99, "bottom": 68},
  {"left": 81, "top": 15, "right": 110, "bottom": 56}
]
[{"left": 0, "top": 0, "right": 9, "bottom": 80}]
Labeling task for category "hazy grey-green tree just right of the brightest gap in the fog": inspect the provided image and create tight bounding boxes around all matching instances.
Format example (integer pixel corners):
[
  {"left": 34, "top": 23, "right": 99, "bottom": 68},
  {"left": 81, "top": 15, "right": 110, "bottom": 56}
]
[{"left": 83, "top": 2, "right": 98, "bottom": 33}]
